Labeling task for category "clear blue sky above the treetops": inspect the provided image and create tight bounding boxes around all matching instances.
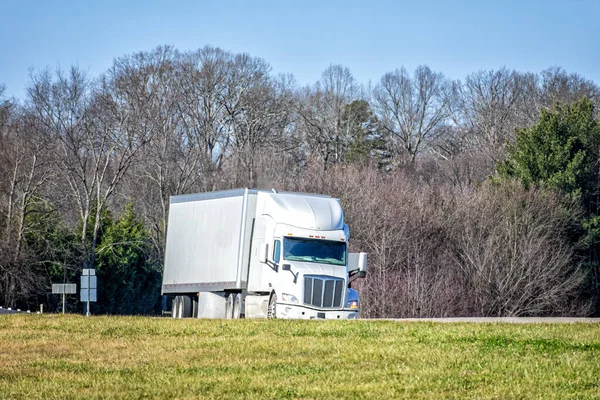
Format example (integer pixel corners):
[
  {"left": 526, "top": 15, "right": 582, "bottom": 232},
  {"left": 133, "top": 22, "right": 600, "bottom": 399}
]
[{"left": 0, "top": 0, "right": 600, "bottom": 99}]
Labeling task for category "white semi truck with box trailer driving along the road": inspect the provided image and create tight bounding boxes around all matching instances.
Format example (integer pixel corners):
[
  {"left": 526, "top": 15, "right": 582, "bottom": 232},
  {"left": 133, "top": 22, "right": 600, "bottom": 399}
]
[{"left": 162, "top": 189, "right": 367, "bottom": 319}]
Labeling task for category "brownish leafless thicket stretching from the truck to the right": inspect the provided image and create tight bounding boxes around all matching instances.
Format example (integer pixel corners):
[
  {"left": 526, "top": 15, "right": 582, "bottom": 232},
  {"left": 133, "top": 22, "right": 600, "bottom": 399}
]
[{"left": 288, "top": 161, "right": 590, "bottom": 317}]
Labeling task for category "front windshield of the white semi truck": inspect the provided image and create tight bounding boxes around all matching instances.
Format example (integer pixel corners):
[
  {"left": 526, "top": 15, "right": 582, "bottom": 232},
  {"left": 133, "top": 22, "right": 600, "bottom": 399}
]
[{"left": 283, "top": 237, "right": 346, "bottom": 265}]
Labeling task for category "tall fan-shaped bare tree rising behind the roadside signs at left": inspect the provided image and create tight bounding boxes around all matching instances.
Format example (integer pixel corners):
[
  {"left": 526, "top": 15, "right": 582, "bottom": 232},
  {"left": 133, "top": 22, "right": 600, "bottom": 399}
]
[{"left": 28, "top": 68, "right": 148, "bottom": 268}]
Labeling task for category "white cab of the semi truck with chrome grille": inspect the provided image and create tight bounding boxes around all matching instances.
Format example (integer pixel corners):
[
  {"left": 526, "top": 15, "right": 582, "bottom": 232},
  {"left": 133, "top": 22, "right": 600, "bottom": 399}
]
[{"left": 246, "top": 192, "right": 366, "bottom": 319}]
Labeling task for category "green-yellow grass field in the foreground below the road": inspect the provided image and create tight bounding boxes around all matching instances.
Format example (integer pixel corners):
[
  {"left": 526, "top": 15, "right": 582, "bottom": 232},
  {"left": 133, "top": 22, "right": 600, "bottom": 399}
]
[{"left": 0, "top": 315, "right": 600, "bottom": 399}]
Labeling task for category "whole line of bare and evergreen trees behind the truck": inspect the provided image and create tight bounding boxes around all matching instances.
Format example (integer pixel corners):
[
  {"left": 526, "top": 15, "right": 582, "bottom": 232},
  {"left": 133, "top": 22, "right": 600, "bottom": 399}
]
[{"left": 0, "top": 46, "right": 600, "bottom": 317}]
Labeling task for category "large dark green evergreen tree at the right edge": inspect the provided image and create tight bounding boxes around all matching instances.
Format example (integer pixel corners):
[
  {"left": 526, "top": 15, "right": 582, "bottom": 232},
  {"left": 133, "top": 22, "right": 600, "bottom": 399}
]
[{"left": 498, "top": 99, "right": 600, "bottom": 311}]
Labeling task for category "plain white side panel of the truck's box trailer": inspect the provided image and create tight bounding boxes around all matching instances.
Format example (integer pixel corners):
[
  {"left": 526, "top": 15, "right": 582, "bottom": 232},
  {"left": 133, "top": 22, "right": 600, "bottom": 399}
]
[{"left": 162, "top": 190, "right": 256, "bottom": 293}]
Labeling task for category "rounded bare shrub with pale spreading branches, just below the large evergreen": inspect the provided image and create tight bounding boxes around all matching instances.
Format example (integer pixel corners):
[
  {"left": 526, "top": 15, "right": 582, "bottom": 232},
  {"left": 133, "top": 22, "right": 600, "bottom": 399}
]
[{"left": 453, "top": 182, "right": 590, "bottom": 316}]
